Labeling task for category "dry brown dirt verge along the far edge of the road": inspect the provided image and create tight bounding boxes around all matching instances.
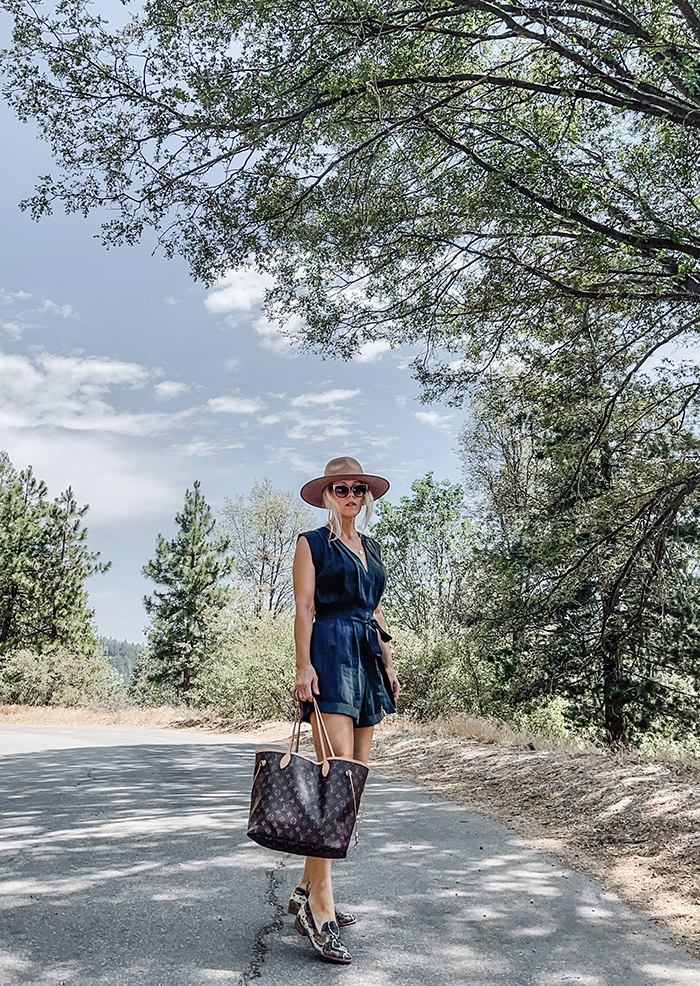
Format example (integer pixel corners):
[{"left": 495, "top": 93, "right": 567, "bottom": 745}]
[{"left": 0, "top": 706, "right": 700, "bottom": 958}]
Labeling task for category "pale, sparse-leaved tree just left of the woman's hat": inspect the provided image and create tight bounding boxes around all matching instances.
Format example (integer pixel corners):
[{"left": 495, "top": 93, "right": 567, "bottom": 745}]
[{"left": 223, "top": 478, "right": 313, "bottom": 616}]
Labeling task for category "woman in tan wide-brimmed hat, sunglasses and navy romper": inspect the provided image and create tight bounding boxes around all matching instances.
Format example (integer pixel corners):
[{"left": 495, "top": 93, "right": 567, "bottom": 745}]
[{"left": 289, "top": 456, "right": 400, "bottom": 964}]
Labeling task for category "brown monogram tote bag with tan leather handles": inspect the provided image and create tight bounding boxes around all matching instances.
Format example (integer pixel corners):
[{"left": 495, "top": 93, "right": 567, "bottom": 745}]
[{"left": 248, "top": 699, "right": 369, "bottom": 859}]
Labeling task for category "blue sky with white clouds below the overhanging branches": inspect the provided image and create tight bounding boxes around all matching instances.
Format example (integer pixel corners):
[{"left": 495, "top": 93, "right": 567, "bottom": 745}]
[{"left": 0, "top": 92, "right": 463, "bottom": 640}]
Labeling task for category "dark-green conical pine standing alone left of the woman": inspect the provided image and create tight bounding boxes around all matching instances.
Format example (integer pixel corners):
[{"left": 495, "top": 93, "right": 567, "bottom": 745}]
[{"left": 143, "top": 481, "right": 231, "bottom": 705}]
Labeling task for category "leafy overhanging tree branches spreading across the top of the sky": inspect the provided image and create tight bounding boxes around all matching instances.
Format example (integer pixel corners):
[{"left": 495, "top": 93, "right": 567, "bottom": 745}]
[{"left": 3, "top": 0, "right": 700, "bottom": 399}]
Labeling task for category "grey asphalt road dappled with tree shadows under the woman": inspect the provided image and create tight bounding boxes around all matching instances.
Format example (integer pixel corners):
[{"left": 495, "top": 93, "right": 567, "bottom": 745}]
[{"left": 0, "top": 726, "right": 700, "bottom": 986}]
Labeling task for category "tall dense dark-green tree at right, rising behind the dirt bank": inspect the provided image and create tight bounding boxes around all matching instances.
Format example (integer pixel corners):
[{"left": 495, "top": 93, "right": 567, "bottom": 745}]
[{"left": 462, "top": 323, "right": 700, "bottom": 745}]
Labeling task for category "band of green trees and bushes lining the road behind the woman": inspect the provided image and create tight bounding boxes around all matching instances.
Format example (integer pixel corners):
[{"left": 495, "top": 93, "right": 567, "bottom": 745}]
[{"left": 0, "top": 450, "right": 700, "bottom": 758}]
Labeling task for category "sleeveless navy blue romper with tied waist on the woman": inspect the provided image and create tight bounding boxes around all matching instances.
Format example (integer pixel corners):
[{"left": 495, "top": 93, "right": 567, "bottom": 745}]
[{"left": 299, "top": 527, "right": 396, "bottom": 726}]
